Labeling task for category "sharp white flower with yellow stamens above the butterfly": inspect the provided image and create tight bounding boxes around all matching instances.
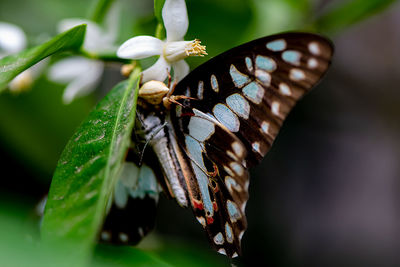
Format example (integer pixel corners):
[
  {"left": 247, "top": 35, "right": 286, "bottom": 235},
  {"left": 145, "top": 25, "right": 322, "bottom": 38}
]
[{"left": 117, "top": 0, "right": 206, "bottom": 83}]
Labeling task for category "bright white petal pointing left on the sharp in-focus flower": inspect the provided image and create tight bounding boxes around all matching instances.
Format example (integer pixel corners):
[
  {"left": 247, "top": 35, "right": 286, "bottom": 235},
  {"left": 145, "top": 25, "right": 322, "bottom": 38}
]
[{"left": 117, "top": 35, "right": 164, "bottom": 59}]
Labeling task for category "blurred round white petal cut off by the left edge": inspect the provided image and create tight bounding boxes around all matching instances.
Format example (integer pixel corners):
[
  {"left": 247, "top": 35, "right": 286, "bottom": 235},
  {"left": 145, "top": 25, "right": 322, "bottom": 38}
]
[{"left": 0, "top": 22, "right": 26, "bottom": 56}]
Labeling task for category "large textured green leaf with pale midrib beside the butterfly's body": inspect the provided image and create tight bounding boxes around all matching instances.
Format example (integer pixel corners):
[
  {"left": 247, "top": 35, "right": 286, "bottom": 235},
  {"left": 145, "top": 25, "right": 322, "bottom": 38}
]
[{"left": 42, "top": 68, "right": 140, "bottom": 266}]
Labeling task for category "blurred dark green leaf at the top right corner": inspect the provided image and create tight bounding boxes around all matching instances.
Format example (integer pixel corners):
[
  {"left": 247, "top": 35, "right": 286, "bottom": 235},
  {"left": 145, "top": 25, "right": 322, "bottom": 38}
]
[{"left": 315, "top": 0, "right": 396, "bottom": 32}]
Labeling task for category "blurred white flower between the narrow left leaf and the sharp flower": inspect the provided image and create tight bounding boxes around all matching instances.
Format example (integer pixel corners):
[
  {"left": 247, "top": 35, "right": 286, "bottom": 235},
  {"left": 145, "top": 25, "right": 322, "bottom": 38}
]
[{"left": 48, "top": 15, "right": 116, "bottom": 104}]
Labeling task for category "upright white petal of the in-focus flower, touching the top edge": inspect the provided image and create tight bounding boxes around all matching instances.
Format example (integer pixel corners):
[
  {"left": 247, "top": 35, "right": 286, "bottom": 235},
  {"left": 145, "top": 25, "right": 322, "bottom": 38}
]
[{"left": 162, "top": 0, "right": 189, "bottom": 42}]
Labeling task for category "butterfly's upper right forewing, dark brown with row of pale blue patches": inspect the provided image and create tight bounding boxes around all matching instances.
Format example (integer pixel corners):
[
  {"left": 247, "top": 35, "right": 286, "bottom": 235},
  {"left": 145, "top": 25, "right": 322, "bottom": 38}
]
[{"left": 174, "top": 33, "right": 333, "bottom": 166}]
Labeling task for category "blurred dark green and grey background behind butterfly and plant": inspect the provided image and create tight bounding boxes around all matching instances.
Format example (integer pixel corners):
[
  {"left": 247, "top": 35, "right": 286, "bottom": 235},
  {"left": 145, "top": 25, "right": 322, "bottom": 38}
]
[{"left": 0, "top": 0, "right": 400, "bottom": 266}]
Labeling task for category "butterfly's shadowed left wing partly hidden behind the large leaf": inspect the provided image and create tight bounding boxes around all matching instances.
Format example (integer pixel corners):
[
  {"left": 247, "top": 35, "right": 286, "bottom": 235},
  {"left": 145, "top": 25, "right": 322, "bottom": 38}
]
[{"left": 100, "top": 150, "right": 161, "bottom": 245}]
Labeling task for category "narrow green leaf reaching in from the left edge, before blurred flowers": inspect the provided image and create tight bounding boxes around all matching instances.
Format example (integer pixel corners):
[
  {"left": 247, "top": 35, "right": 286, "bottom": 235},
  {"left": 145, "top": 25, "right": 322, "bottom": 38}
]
[{"left": 0, "top": 25, "right": 86, "bottom": 92}]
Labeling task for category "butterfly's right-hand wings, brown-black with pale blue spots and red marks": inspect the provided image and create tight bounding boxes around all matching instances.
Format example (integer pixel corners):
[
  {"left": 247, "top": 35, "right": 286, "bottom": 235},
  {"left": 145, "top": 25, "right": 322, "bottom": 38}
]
[{"left": 171, "top": 33, "right": 333, "bottom": 257}]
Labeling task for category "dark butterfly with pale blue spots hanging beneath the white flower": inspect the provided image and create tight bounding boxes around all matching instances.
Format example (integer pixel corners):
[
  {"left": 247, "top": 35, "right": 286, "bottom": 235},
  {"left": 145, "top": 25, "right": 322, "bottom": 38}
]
[{"left": 100, "top": 33, "right": 333, "bottom": 258}]
